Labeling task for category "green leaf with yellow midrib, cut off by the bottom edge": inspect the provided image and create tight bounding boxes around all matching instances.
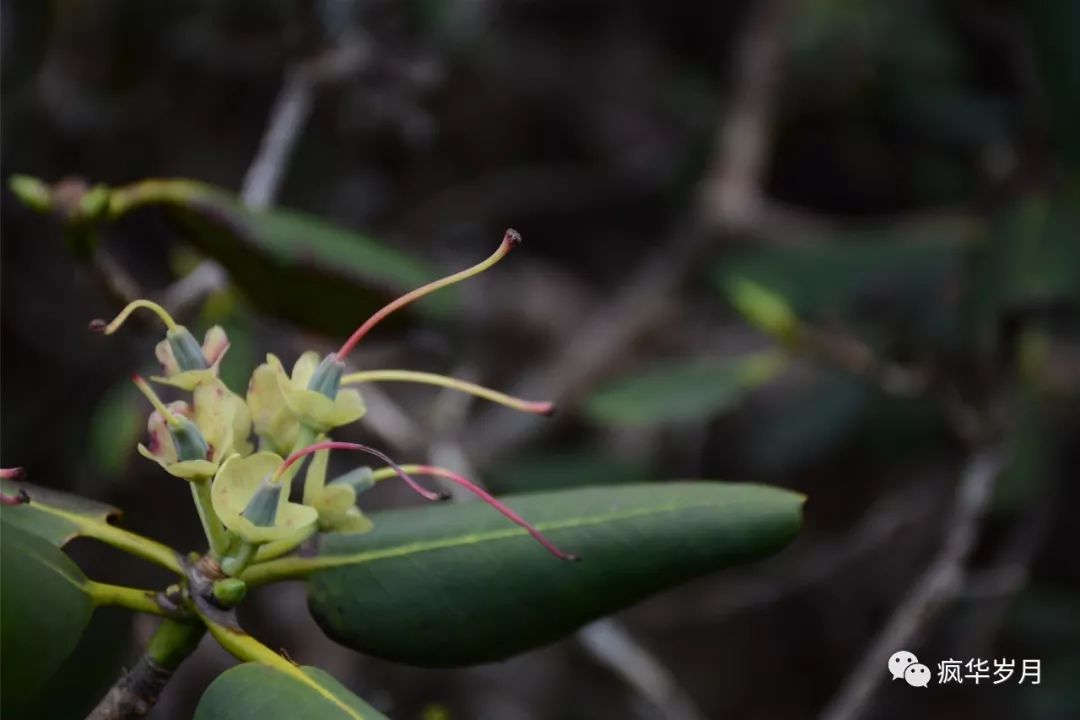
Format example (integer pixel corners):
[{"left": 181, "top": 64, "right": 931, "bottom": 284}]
[{"left": 194, "top": 663, "right": 386, "bottom": 720}]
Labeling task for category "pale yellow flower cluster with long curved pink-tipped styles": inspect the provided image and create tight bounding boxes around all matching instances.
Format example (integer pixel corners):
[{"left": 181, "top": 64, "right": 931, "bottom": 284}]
[{"left": 97, "top": 230, "right": 573, "bottom": 575}]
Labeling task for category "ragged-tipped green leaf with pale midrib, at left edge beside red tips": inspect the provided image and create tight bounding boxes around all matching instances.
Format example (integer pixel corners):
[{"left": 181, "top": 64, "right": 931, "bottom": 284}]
[{"left": 0, "top": 480, "right": 120, "bottom": 547}]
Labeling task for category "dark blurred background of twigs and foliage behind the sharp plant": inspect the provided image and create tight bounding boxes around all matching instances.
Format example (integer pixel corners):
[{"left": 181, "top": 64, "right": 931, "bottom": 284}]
[{"left": 0, "top": 0, "right": 1080, "bottom": 720}]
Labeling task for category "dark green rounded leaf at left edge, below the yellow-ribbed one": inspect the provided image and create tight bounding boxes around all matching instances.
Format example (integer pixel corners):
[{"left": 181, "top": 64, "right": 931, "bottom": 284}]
[{"left": 0, "top": 520, "right": 93, "bottom": 718}]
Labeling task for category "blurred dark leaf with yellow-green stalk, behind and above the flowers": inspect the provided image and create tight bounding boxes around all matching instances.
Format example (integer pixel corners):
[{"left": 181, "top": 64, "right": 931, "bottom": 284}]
[{"left": 110, "top": 179, "right": 449, "bottom": 335}]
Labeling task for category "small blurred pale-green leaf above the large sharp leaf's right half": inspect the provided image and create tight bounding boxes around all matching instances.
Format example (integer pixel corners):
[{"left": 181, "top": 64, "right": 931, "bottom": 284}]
[{"left": 585, "top": 352, "right": 786, "bottom": 425}]
